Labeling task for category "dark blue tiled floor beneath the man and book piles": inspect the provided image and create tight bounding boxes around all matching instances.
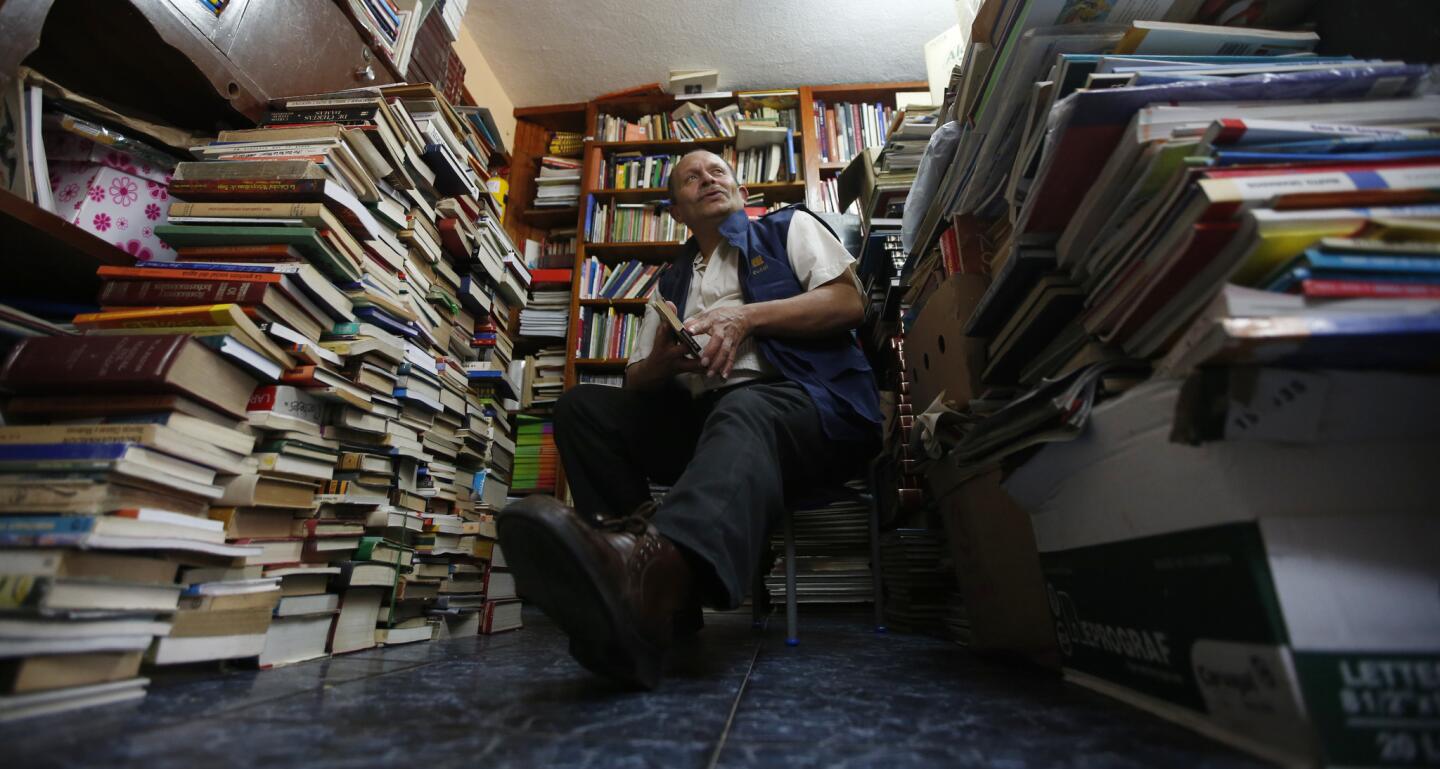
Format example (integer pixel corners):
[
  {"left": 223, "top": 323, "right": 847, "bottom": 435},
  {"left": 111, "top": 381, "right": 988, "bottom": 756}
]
[{"left": 11, "top": 611, "right": 1257, "bottom": 769}]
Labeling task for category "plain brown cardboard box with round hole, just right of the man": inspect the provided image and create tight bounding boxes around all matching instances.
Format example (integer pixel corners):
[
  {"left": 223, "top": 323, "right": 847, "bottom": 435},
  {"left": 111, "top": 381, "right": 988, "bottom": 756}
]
[{"left": 904, "top": 275, "right": 989, "bottom": 410}]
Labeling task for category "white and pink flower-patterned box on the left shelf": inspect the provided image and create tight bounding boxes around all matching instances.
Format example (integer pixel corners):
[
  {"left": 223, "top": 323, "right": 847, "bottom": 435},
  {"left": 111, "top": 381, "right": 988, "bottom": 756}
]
[{"left": 46, "top": 134, "right": 174, "bottom": 261}]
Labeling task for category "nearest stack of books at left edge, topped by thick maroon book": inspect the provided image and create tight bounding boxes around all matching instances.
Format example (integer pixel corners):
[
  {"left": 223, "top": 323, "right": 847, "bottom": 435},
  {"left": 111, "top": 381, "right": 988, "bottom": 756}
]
[{"left": 0, "top": 331, "right": 274, "bottom": 719}]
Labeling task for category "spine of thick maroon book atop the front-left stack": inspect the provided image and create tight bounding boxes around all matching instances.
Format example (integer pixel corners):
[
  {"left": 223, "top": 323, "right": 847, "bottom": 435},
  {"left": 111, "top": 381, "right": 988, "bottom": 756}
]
[{"left": 0, "top": 334, "right": 189, "bottom": 393}]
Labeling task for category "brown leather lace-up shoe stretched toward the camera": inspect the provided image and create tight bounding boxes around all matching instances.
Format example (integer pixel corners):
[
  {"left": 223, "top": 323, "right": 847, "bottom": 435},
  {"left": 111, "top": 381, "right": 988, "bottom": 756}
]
[{"left": 497, "top": 495, "right": 691, "bottom": 688}]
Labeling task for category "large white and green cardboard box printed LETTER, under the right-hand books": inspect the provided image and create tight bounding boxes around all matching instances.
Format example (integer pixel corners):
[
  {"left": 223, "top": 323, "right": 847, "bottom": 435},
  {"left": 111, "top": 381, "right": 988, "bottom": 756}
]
[{"left": 1005, "top": 380, "right": 1440, "bottom": 766}]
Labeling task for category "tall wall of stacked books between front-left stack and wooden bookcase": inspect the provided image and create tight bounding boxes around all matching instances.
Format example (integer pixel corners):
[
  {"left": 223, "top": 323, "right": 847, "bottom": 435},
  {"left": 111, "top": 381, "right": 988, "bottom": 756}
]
[{"left": 112, "top": 85, "right": 528, "bottom": 664}]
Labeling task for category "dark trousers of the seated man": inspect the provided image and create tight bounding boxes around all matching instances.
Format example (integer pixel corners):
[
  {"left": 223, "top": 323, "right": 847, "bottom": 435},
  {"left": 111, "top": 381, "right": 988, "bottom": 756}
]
[{"left": 554, "top": 380, "right": 874, "bottom": 609}]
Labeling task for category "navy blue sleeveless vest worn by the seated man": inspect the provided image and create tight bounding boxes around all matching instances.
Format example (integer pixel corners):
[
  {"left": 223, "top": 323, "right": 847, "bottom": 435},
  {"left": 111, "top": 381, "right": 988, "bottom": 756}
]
[{"left": 658, "top": 204, "right": 881, "bottom": 441}]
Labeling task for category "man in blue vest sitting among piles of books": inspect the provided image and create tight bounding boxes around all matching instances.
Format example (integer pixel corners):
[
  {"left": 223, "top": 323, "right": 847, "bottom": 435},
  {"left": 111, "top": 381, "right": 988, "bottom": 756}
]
[{"left": 498, "top": 150, "right": 880, "bottom": 688}]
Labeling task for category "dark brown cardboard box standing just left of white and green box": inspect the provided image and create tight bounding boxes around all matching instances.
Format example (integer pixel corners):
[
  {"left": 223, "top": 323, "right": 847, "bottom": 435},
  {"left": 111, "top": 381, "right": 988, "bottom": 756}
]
[{"left": 940, "top": 471, "right": 1060, "bottom": 667}]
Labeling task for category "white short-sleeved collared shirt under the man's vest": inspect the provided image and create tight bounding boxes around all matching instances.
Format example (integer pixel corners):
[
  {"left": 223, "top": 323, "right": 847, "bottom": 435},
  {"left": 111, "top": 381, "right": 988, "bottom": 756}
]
[{"left": 629, "top": 213, "right": 864, "bottom": 396}]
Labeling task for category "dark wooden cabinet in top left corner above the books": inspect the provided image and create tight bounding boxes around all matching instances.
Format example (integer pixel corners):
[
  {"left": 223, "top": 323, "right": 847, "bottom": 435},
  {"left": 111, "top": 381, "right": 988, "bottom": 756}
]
[{"left": 0, "top": 0, "right": 402, "bottom": 131}]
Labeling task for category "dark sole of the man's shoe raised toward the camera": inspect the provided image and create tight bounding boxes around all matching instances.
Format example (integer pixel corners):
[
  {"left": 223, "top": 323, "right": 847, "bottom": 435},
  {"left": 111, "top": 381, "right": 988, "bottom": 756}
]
[{"left": 497, "top": 510, "right": 661, "bottom": 688}]
